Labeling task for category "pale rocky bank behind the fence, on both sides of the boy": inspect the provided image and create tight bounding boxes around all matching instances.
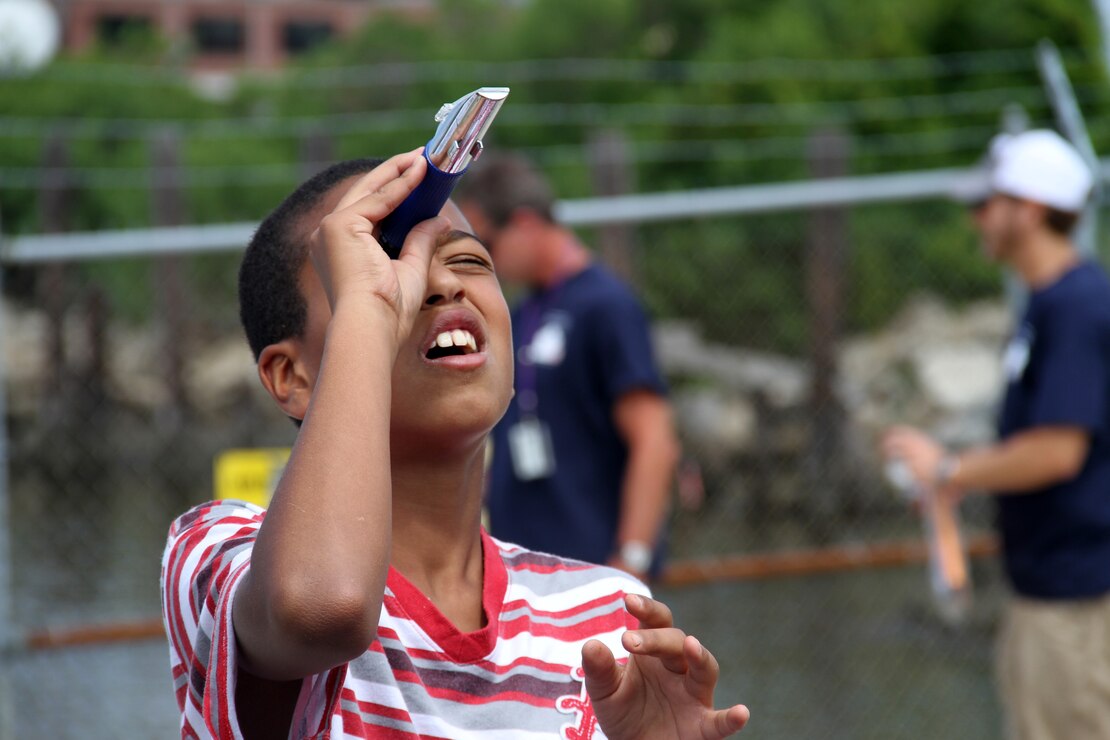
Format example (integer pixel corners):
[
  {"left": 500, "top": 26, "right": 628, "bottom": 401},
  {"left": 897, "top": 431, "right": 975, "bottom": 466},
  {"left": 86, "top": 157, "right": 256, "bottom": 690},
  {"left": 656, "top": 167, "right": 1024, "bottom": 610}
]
[{"left": 2, "top": 297, "right": 1011, "bottom": 501}]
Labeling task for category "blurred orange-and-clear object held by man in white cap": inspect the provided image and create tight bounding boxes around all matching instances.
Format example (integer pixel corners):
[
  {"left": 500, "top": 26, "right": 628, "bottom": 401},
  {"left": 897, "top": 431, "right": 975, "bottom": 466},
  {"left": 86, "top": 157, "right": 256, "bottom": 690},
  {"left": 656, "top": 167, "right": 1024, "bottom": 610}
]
[{"left": 886, "top": 459, "right": 971, "bottom": 625}]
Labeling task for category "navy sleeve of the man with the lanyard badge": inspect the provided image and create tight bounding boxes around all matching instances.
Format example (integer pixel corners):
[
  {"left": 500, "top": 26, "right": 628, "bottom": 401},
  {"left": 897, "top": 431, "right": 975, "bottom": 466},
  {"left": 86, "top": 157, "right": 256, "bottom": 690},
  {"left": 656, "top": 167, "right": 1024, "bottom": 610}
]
[{"left": 593, "top": 292, "right": 667, "bottom": 399}]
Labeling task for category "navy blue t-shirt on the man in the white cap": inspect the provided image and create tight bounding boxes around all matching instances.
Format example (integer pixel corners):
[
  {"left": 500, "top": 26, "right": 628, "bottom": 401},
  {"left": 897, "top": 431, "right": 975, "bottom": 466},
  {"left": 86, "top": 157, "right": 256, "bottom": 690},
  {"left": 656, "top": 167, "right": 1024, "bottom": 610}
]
[{"left": 998, "top": 263, "right": 1110, "bottom": 599}]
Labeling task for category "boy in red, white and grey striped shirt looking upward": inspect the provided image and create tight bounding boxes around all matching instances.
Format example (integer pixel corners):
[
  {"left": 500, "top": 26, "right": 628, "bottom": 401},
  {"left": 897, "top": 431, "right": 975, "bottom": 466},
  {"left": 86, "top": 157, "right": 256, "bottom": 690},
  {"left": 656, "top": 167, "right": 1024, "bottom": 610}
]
[{"left": 162, "top": 150, "right": 748, "bottom": 739}]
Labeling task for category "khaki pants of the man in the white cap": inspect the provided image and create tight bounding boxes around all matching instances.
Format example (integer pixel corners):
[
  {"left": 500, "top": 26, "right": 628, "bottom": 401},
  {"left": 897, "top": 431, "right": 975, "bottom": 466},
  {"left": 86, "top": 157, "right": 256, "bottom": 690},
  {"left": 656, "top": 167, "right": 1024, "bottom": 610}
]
[{"left": 998, "top": 596, "right": 1110, "bottom": 740}]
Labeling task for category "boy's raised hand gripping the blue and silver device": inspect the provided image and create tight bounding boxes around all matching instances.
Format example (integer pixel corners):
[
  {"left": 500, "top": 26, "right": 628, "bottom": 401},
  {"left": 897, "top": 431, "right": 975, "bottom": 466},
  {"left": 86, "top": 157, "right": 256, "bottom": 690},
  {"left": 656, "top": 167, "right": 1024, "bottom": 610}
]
[{"left": 310, "top": 149, "right": 448, "bottom": 342}]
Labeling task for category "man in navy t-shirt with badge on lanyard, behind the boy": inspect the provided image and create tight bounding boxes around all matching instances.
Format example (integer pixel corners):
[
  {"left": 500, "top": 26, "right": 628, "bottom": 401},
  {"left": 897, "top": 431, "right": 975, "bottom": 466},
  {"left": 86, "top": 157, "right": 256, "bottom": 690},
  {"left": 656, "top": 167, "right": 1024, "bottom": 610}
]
[{"left": 456, "top": 158, "right": 678, "bottom": 577}]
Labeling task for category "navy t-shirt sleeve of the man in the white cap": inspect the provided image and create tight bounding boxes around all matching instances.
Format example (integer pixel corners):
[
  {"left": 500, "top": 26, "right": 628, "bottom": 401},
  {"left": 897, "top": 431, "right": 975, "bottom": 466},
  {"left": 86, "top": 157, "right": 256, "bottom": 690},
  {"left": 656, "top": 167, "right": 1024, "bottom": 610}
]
[{"left": 1029, "top": 310, "right": 1110, "bottom": 434}]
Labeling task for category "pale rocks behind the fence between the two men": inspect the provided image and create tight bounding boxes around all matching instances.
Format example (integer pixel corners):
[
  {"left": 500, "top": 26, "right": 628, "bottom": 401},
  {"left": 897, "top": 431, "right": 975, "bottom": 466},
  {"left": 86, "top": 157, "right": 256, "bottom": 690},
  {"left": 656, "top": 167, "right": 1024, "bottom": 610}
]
[{"left": 655, "top": 296, "right": 1011, "bottom": 503}]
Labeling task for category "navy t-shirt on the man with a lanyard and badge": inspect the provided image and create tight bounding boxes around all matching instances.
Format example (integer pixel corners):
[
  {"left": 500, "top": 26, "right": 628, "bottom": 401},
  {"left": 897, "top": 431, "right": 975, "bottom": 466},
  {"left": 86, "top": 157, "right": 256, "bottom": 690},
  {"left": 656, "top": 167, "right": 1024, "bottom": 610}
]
[{"left": 486, "top": 265, "right": 666, "bottom": 562}]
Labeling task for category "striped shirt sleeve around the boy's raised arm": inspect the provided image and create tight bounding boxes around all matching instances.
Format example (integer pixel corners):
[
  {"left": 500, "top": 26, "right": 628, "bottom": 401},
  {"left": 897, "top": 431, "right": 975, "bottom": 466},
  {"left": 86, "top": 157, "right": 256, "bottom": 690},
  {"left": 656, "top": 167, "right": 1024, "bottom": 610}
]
[{"left": 161, "top": 500, "right": 345, "bottom": 740}]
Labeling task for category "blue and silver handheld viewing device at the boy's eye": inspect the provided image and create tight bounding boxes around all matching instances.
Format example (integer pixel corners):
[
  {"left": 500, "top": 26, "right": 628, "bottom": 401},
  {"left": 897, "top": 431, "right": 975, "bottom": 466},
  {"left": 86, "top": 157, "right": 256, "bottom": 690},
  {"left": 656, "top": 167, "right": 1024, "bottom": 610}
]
[{"left": 377, "top": 88, "right": 508, "bottom": 260}]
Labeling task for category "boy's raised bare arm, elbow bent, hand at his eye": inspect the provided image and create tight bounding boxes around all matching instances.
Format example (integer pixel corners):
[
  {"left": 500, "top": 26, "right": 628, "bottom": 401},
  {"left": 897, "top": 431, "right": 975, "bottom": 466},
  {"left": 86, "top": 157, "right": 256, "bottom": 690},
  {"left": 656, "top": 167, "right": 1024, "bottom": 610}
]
[{"left": 233, "top": 152, "right": 446, "bottom": 680}]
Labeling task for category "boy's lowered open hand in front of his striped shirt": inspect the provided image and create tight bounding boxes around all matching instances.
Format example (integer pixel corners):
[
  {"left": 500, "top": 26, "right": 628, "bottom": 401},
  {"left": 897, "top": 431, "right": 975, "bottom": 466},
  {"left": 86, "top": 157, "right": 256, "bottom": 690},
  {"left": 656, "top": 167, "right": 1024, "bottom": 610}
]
[{"left": 582, "top": 596, "right": 749, "bottom": 740}]
